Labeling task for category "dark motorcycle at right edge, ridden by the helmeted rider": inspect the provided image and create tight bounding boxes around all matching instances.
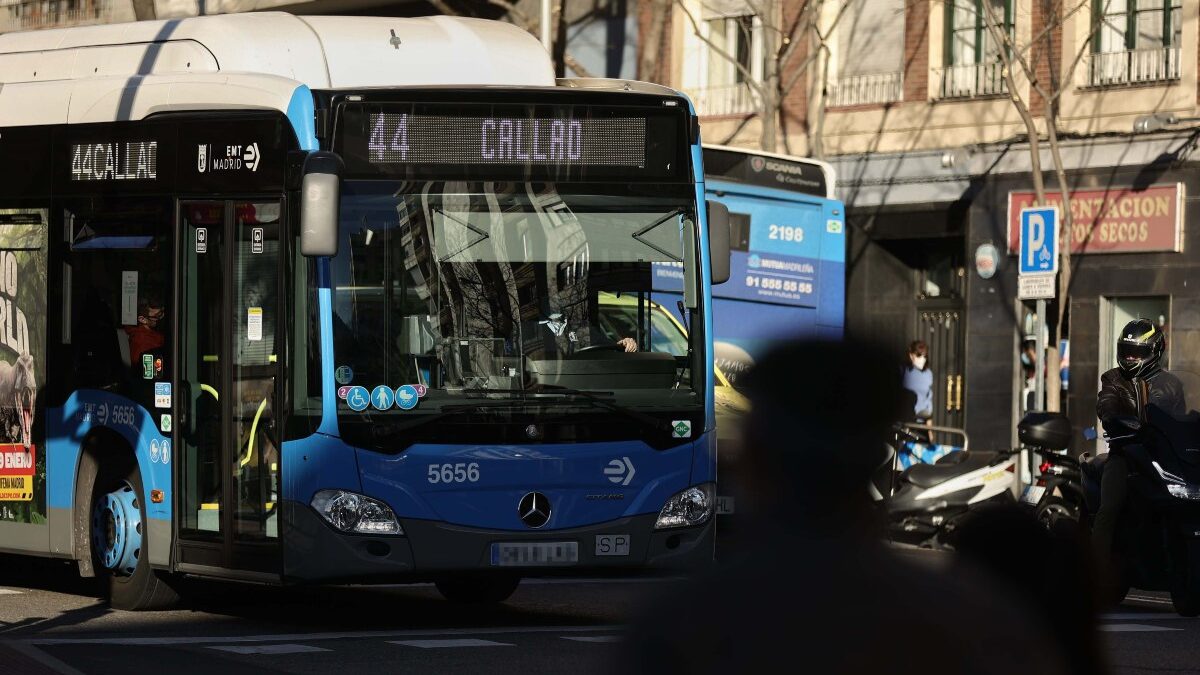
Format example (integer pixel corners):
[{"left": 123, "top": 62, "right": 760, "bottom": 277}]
[{"left": 1084, "top": 378, "right": 1200, "bottom": 616}]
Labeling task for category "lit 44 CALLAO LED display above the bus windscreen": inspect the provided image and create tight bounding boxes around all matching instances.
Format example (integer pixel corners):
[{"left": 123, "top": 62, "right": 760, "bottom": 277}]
[{"left": 367, "top": 113, "right": 646, "bottom": 168}]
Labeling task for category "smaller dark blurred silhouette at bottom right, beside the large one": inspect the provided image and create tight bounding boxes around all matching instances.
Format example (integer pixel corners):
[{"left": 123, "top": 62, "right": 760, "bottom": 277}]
[{"left": 953, "top": 504, "right": 1108, "bottom": 675}]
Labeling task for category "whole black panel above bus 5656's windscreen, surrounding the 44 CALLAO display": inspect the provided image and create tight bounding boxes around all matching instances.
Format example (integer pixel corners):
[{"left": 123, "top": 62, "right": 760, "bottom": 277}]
[{"left": 343, "top": 99, "right": 694, "bottom": 183}]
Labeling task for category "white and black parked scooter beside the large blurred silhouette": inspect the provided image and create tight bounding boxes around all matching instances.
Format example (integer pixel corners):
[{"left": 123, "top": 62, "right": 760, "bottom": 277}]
[{"left": 871, "top": 426, "right": 1016, "bottom": 548}]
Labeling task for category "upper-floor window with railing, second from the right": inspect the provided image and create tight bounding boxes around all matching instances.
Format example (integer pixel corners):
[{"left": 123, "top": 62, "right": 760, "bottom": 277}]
[{"left": 935, "top": 0, "right": 1013, "bottom": 98}]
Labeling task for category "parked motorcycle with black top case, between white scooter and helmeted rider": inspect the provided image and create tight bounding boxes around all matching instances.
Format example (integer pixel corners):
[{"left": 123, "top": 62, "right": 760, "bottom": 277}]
[{"left": 1016, "top": 412, "right": 1086, "bottom": 530}]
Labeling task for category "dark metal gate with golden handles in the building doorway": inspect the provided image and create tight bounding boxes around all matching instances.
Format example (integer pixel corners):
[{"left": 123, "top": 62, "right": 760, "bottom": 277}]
[{"left": 917, "top": 306, "right": 966, "bottom": 429}]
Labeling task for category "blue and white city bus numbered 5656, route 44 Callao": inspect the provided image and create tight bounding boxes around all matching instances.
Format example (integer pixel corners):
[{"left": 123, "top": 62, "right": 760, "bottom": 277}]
[{"left": 0, "top": 13, "right": 728, "bottom": 609}]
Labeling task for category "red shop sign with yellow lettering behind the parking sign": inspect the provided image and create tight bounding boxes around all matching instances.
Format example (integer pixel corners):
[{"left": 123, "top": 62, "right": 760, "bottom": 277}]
[{"left": 1008, "top": 184, "right": 1183, "bottom": 255}]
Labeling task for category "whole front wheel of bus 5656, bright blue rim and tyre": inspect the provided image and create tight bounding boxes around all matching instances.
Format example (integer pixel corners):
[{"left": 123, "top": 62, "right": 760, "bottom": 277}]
[{"left": 91, "top": 460, "right": 179, "bottom": 610}]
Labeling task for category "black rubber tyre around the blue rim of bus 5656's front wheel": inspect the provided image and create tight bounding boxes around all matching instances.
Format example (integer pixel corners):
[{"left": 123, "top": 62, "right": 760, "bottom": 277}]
[{"left": 88, "top": 455, "right": 179, "bottom": 611}]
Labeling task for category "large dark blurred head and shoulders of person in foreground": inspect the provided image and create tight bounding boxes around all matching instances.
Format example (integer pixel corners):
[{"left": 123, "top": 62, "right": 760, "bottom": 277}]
[{"left": 623, "top": 341, "right": 1068, "bottom": 675}]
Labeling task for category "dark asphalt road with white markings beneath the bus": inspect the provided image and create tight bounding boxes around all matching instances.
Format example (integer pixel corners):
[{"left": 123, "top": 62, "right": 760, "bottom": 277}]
[{"left": 0, "top": 552, "right": 1200, "bottom": 675}]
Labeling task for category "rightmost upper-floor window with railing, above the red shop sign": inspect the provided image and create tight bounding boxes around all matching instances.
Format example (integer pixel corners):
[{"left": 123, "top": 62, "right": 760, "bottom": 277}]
[{"left": 1087, "top": 0, "right": 1183, "bottom": 86}]
